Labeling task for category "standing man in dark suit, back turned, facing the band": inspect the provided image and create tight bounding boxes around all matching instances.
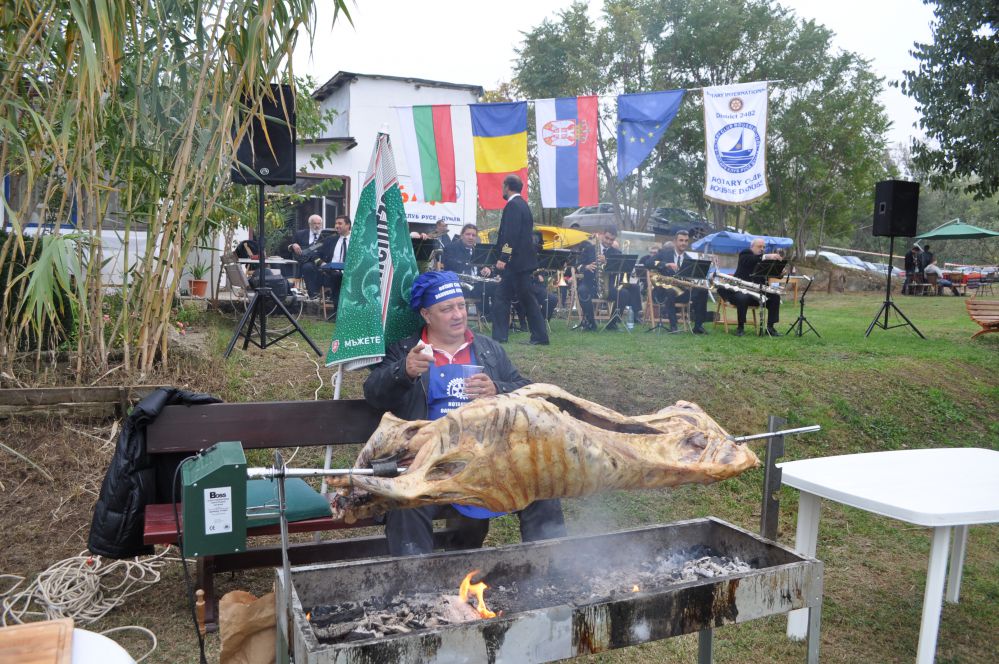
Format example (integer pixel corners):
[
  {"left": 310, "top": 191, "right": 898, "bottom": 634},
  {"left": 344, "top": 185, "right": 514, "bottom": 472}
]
[{"left": 493, "top": 175, "right": 548, "bottom": 346}]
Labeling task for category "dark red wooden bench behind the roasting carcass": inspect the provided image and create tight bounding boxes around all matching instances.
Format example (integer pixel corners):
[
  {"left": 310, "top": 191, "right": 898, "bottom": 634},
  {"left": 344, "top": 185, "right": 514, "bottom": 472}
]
[{"left": 143, "top": 400, "right": 462, "bottom": 630}]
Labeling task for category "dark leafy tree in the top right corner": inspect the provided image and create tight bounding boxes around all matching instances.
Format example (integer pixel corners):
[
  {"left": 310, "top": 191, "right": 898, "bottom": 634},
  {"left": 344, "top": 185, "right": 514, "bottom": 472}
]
[{"left": 902, "top": 0, "right": 999, "bottom": 198}]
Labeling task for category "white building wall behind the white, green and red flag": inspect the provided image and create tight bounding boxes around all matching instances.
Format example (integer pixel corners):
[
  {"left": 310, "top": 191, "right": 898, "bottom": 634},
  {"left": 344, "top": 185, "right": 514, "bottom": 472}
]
[{"left": 298, "top": 76, "right": 478, "bottom": 233}]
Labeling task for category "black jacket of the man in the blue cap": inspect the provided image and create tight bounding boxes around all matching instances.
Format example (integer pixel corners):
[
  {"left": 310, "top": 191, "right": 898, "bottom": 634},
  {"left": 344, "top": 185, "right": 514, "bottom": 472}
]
[{"left": 364, "top": 334, "right": 531, "bottom": 420}]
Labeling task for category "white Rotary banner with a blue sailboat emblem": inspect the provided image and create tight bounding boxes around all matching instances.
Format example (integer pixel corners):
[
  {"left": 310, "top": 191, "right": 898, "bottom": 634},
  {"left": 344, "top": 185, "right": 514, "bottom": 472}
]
[{"left": 704, "top": 82, "right": 768, "bottom": 205}]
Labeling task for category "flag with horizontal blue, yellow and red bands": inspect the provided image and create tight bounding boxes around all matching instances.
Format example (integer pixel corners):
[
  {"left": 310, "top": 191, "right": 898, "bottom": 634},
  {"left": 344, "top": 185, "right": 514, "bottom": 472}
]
[{"left": 470, "top": 101, "right": 527, "bottom": 210}]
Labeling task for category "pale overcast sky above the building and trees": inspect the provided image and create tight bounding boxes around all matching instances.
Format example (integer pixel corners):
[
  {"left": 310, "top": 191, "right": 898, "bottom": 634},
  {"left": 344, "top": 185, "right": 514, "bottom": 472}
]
[{"left": 295, "top": 0, "right": 933, "bottom": 143}]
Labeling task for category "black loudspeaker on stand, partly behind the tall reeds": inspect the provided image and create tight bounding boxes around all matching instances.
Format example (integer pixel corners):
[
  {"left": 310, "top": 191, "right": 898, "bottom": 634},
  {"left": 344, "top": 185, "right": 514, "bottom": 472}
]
[{"left": 231, "top": 84, "right": 296, "bottom": 185}]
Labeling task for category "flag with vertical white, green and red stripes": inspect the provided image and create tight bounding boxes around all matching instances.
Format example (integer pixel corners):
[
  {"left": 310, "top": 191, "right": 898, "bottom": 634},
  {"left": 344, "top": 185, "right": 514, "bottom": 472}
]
[{"left": 397, "top": 105, "right": 458, "bottom": 203}]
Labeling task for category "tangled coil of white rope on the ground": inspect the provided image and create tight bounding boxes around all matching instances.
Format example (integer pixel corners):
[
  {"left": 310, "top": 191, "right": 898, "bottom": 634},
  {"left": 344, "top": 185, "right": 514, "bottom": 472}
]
[{"left": 0, "top": 547, "right": 178, "bottom": 662}]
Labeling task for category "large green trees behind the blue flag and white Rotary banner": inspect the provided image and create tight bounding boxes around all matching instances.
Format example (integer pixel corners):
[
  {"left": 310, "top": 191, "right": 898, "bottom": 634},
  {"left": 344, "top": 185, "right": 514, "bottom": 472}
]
[{"left": 515, "top": 0, "right": 888, "bottom": 254}]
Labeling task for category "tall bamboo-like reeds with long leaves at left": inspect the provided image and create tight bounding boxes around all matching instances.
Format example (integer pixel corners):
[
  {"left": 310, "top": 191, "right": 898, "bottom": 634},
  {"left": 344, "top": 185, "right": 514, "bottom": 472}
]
[{"left": 0, "top": 0, "right": 346, "bottom": 378}]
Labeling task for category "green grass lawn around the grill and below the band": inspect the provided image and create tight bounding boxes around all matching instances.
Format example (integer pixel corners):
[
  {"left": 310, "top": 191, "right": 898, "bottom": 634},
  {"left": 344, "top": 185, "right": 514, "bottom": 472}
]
[{"left": 135, "top": 295, "right": 999, "bottom": 663}]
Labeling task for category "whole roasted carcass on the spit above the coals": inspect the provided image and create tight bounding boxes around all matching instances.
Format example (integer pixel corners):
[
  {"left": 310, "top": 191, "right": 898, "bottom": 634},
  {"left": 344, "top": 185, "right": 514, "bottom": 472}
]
[{"left": 331, "top": 384, "right": 759, "bottom": 521}]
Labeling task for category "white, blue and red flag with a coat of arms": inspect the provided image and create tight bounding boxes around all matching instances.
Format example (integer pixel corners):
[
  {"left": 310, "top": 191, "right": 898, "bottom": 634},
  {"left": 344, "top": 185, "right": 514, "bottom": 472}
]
[{"left": 534, "top": 96, "right": 599, "bottom": 208}]
